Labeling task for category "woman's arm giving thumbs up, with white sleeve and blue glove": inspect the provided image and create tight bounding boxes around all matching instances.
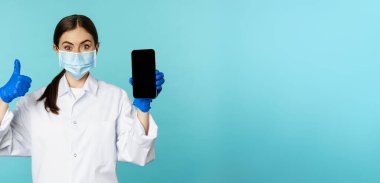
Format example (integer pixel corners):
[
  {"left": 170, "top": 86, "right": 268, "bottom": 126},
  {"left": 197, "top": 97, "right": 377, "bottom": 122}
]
[{"left": 0, "top": 59, "right": 32, "bottom": 156}]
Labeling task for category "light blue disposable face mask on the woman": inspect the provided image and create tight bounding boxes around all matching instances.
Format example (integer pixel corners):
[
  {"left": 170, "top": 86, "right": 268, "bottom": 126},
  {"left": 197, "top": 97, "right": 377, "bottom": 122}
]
[{"left": 58, "top": 50, "right": 96, "bottom": 80}]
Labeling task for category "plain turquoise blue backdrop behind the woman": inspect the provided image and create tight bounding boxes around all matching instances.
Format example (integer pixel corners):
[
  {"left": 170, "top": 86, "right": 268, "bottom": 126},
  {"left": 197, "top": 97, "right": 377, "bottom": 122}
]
[{"left": 0, "top": 0, "right": 380, "bottom": 183}]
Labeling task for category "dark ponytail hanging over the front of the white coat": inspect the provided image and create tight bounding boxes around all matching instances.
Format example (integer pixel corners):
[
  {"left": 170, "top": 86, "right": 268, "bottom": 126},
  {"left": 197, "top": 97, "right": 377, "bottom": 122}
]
[{"left": 37, "top": 69, "right": 65, "bottom": 115}]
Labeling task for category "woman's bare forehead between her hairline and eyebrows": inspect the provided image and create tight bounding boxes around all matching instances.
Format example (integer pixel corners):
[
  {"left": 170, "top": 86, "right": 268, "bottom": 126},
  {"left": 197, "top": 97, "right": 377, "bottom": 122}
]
[{"left": 59, "top": 27, "right": 94, "bottom": 45}]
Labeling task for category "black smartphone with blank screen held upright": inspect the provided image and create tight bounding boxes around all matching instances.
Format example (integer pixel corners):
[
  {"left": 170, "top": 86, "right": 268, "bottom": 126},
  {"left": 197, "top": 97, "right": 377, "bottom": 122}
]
[{"left": 132, "top": 49, "right": 157, "bottom": 99}]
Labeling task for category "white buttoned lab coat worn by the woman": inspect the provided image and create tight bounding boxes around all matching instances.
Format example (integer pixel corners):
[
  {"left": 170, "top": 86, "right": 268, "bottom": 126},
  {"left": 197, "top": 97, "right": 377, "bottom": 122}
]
[{"left": 0, "top": 74, "right": 157, "bottom": 183}]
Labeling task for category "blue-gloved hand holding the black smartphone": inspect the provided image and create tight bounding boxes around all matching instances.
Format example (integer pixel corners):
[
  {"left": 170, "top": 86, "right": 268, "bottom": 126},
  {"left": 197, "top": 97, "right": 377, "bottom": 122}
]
[{"left": 129, "top": 69, "right": 165, "bottom": 112}]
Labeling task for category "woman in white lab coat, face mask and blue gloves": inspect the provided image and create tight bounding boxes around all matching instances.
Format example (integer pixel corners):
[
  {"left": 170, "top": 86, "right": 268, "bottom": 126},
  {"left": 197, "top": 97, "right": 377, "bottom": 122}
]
[{"left": 0, "top": 15, "right": 164, "bottom": 183}]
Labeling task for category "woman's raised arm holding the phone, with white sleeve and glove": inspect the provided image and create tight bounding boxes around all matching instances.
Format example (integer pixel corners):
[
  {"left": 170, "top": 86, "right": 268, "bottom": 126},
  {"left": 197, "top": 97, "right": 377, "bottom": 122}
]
[{"left": 116, "top": 70, "right": 165, "bottom": 166}]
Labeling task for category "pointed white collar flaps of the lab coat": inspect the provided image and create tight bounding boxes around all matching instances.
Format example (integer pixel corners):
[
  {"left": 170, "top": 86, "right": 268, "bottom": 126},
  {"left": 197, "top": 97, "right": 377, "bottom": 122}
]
[{"left": 58, "top": 73, "right": 98, "bottom": 97}]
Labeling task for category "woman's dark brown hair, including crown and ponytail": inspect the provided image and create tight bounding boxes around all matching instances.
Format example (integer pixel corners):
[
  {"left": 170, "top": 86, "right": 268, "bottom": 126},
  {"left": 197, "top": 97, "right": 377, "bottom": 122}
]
[{"left": 37, "top": 15, "right": 99, "bottom": 115}]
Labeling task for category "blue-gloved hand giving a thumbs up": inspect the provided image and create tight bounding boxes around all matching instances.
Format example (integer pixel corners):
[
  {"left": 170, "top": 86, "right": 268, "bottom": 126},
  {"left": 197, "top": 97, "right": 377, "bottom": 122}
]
[{"left": 0, "top": 59, "right": 32, "bottom": 103}]
